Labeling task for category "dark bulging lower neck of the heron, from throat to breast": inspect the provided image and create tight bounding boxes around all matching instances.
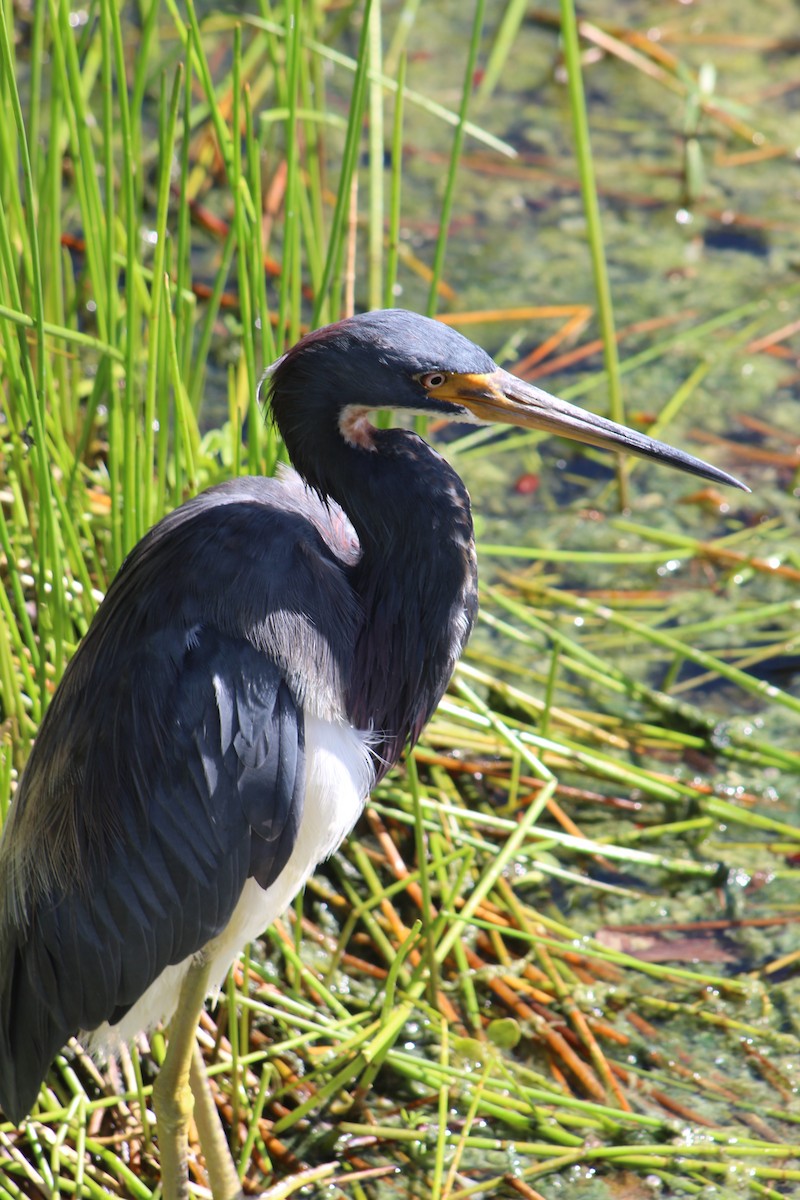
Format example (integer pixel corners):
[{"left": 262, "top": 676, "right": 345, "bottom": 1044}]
[{"left": 331, "top": 430, "right": 477, "bottom": 775}]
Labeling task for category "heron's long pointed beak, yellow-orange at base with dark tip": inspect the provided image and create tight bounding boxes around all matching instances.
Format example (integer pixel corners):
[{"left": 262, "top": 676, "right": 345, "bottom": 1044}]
[{"left": 432, "top": 368, "right": 750, "bottom": 492}]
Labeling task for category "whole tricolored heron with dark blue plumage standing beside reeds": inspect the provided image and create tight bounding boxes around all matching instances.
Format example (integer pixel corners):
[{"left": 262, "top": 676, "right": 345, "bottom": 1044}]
[{"left": 0, "top": 310, "right": 744, "bottom": 1200}]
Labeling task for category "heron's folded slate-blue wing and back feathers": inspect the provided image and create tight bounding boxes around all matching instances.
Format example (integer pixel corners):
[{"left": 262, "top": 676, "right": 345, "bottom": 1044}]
[{"left": 0, "top": 472, "right": 355, "bottom": 1116}]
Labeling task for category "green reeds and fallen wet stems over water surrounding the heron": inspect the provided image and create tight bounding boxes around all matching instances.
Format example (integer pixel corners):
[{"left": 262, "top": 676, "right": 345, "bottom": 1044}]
[{"left": 0, "top": 0, "right": 800, "bottom": 1200}]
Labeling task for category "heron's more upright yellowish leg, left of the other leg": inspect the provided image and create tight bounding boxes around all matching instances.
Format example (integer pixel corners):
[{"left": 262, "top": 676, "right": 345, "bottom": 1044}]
[{"left": 152, "top": 955, "right": 216, "bottom": 1200}]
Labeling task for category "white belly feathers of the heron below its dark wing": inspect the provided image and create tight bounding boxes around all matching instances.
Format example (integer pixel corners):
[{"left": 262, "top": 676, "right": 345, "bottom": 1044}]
[{"left": 86, "top": 716, "right": 374, "bottom": 1051}]
